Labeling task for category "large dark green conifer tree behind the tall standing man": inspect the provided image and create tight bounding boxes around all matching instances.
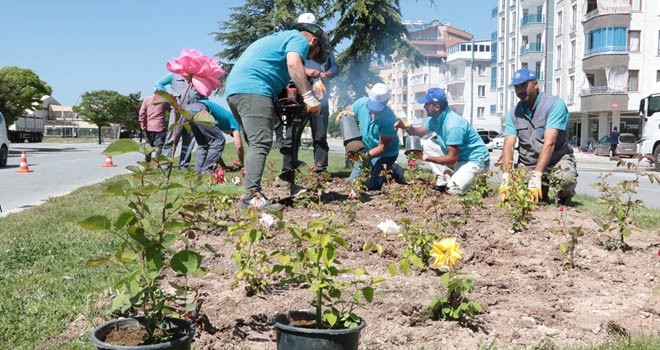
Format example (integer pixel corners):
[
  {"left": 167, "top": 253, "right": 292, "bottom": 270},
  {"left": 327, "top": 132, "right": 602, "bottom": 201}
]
[{"left": 215, "top": 0, "right": 426, "bottom": 106}]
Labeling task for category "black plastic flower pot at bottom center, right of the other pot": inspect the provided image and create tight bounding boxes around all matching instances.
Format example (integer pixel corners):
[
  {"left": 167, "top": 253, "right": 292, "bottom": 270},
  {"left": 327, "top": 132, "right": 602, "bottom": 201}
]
[{"left": 275, "top": 311, "right": 367, "bottom": 350}]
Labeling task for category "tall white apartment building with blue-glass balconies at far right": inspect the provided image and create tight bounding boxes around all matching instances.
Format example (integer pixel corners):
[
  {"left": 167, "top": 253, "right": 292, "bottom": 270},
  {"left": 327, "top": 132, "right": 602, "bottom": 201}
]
[{"left": 493, "top": 0, "right": 660, "bottom": 147}]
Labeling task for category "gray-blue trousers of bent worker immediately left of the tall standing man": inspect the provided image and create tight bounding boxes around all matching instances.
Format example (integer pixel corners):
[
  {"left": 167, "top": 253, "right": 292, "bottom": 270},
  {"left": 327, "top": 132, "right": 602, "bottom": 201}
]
[{"left": 191, "top": 123, "right": 225, "bottom": 173}]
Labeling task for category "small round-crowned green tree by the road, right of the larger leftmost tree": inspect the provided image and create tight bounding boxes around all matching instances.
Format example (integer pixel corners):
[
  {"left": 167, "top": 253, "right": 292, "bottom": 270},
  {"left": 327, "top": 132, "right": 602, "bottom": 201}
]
[{"left": 73, "top": 90, "right": 137, "bottom": 144}]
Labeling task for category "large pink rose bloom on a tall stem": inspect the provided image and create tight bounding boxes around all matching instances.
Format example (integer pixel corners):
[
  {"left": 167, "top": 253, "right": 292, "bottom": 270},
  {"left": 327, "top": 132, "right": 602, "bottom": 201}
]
[{"left": 167, "top": 49, "right": 225, "bottom": 97}]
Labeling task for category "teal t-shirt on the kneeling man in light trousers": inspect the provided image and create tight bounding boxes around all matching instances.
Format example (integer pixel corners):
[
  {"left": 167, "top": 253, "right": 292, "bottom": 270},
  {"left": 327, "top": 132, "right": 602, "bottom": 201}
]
[{"left": 424, "top": 108, "right": 490, "bottom": 166}]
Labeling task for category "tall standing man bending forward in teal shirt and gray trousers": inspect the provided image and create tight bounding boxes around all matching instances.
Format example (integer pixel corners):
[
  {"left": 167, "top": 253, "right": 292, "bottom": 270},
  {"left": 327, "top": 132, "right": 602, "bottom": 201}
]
[{"left": 226, "top": 23, "right": 329, "bottom": 210}]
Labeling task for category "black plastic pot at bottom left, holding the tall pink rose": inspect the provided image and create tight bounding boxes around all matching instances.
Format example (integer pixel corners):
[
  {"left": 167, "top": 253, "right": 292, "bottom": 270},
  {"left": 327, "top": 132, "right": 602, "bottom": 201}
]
[{"left": 91, "top": 317, "right": 195, "bottom": 350}]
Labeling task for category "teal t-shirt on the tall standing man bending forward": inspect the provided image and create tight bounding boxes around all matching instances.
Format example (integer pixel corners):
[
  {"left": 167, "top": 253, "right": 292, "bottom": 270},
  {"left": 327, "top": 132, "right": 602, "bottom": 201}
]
[{"left": 225, "top": 30, "right": 309, "bottom": 100}]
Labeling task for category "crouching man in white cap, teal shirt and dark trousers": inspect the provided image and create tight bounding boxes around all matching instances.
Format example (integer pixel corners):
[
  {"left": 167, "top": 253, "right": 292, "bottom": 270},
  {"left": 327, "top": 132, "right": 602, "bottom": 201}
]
[{"left": 350, "top": 83, "right": 406, "bottom": 190}]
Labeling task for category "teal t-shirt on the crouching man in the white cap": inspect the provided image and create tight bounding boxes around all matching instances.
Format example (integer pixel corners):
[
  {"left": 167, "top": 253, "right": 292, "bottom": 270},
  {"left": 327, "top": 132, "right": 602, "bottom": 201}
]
[{"left": 351, "top": 97, "right": 399, "bottom": 157}]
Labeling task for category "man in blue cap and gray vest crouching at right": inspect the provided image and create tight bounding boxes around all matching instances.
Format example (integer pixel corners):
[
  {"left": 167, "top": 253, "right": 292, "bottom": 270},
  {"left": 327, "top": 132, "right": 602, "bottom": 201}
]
[{"left": 496, "top": 68, "right": 578, "bottom": 204}]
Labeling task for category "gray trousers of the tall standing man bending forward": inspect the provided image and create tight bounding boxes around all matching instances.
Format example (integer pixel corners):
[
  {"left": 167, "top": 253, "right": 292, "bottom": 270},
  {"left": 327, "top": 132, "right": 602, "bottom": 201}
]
[{"left": 227, "top": 94, "right": 276, "bottom": 192}]
